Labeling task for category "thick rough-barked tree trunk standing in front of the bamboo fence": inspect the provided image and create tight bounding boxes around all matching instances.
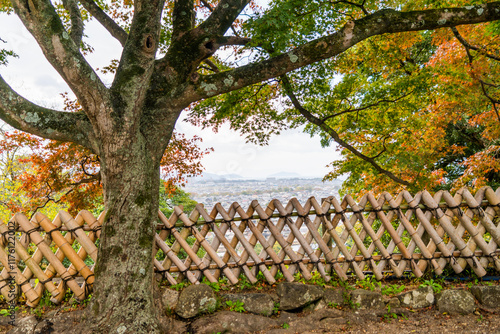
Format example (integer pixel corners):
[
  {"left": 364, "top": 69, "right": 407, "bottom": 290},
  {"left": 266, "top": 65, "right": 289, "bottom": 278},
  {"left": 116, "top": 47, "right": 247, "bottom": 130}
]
[{"left": 85, "top": 131, "right": 166, "bottom": 333}]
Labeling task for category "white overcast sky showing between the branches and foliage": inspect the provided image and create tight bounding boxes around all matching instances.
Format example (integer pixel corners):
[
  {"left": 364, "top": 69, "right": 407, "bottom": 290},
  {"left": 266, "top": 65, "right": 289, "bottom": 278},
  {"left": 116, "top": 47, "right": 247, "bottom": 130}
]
[{"left": 0, "top": 14, "right": 339, "bottom": 177}]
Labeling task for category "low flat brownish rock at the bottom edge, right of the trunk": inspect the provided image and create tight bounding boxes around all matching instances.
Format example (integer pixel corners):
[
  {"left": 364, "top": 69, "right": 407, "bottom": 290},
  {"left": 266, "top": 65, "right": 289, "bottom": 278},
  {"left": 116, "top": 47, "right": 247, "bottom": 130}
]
[{"left": 191, "top": 311, "right": 278, "bottom": 334}]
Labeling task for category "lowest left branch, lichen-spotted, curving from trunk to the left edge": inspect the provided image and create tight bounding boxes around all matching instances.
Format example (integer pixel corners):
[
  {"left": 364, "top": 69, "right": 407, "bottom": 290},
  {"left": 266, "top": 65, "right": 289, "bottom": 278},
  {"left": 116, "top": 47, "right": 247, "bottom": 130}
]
[{"left": 0, "top": 76, "right": 95, "bottom": 151}]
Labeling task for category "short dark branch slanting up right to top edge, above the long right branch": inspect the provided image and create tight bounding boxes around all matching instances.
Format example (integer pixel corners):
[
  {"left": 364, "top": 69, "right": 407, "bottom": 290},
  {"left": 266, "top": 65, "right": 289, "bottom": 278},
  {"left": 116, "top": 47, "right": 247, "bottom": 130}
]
[{"left": 199, "top": 0, "right": 250, "bottom": 36}]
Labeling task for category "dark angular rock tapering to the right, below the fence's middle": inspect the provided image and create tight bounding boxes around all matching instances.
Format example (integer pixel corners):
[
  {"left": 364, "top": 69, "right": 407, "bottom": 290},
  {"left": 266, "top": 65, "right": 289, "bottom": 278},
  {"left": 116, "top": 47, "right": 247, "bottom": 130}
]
[{"left": 276, "top": 282, "right": 323, "bottom": 311}]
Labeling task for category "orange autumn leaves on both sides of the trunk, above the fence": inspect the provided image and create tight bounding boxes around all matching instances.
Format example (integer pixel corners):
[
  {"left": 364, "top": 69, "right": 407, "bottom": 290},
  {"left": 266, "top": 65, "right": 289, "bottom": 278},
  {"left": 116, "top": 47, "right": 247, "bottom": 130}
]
[{"left": 0, "top": 94, "right": 212, "bottom": 218}]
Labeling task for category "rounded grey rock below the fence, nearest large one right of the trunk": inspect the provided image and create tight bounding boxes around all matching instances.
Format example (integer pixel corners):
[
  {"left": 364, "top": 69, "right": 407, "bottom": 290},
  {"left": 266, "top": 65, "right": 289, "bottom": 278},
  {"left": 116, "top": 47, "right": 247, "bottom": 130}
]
[{"left": 175, "top": 284, "right": 217, "bottom": 319}]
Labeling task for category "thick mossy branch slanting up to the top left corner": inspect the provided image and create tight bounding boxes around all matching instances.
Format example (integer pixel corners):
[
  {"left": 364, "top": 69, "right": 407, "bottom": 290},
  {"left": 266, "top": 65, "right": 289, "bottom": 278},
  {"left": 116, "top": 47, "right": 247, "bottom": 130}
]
[{"left": 12, "top": 0, "right": 108, "bottom": 115}]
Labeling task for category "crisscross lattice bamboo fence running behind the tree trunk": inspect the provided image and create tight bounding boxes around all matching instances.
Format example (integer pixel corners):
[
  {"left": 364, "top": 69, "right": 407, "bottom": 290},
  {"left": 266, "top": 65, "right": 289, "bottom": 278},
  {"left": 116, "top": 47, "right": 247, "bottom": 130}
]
[{"left": 0, "top": 187, "right": 500, "bottom": 307}]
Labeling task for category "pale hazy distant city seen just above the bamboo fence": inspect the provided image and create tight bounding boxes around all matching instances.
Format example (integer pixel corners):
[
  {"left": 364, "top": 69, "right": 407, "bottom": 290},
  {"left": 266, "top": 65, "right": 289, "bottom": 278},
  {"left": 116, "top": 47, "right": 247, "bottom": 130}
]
[{"left": 185, "top": 173, "right": 342, "bottom": 209}]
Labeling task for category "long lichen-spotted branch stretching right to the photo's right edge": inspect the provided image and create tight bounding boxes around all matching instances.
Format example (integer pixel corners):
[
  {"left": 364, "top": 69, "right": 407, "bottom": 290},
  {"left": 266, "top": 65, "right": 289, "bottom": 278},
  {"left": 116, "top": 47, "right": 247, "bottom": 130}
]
[{"left": 193, "top": 1, "right": 500, "bottom": 99}]
